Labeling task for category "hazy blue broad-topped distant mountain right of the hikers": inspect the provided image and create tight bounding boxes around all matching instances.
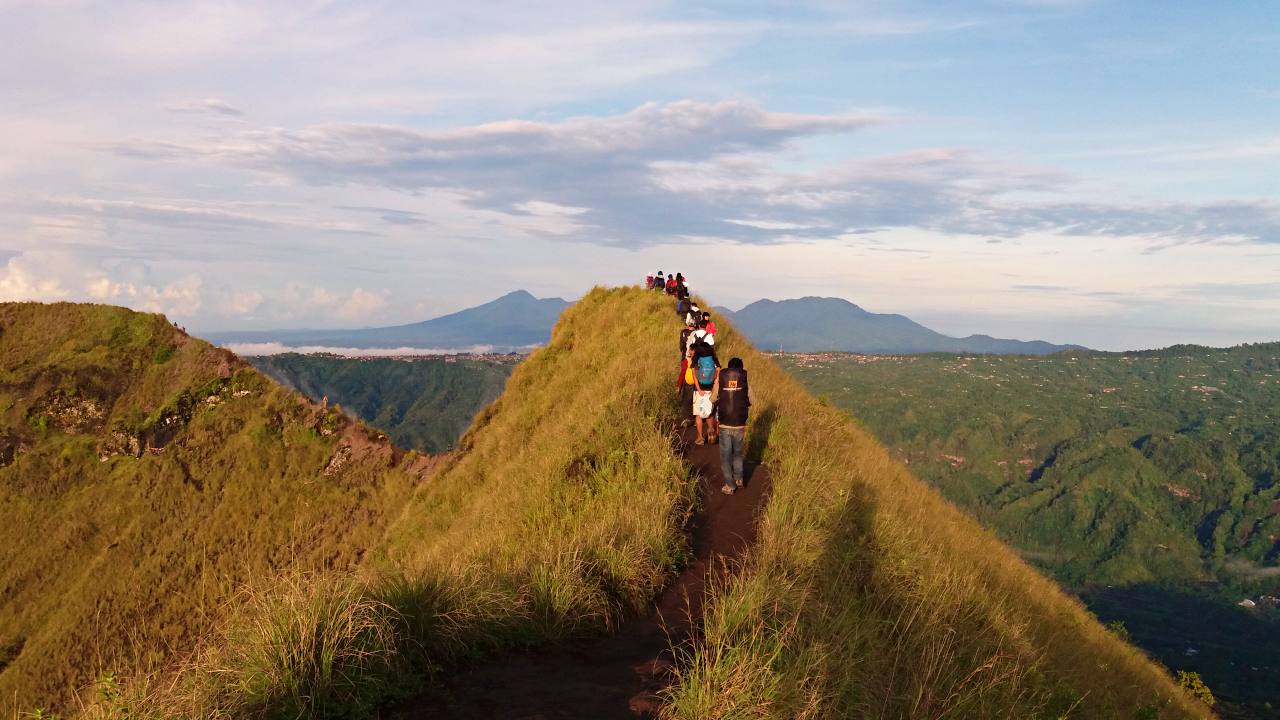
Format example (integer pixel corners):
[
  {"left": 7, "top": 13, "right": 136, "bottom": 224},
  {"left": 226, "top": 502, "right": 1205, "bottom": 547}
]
[{"left": 722, "top": 297, "right": 1080, "bottom": 355}]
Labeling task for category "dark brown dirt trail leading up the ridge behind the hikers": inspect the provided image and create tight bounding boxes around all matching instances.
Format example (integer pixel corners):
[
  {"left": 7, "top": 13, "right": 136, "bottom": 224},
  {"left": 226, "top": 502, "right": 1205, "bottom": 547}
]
[{"left": 393, "top": 429, "right": 769, "bottom": 720}]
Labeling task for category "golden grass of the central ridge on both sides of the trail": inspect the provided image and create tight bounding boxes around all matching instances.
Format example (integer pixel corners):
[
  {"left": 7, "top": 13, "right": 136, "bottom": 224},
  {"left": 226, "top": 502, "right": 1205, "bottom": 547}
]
[{"left": 10, "top": 290, "right": 1208, "bottom": 719}]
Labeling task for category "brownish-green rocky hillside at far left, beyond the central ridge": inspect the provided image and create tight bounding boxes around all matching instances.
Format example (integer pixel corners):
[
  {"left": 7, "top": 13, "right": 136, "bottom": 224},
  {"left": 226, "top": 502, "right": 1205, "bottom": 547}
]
[{"left": 0, "top": 304, "right": 424, "bottom": 716}]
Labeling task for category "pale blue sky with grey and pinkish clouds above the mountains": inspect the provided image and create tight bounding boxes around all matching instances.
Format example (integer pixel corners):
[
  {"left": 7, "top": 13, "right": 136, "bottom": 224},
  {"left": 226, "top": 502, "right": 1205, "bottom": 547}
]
[{"left": 0, "top": 0, "right": 1280, "bottom": 350}]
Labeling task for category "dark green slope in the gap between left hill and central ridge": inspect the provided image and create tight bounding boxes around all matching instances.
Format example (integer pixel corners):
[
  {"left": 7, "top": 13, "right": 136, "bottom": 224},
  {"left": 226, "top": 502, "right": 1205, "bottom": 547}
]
[{"left": 248, "top": 354, "right": 518, "bottom": 452}]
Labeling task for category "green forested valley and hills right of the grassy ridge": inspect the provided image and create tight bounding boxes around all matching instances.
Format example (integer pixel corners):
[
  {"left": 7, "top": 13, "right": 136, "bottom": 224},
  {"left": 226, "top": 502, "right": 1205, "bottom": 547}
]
[{"left": 780, "top": 343, "right": 1280, "bottom": 711}]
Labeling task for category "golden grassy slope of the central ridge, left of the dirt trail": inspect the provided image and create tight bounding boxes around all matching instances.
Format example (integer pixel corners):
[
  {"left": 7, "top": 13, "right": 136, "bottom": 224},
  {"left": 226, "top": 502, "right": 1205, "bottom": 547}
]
[{"left": 74, "top": 290, "right": 694, "bottom": 717}]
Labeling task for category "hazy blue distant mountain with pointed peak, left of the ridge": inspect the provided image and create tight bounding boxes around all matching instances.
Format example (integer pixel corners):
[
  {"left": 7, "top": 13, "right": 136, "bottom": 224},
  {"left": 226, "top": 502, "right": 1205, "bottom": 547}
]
[{"left": 206, "top": 290, "right": 570, "bottom": 350}]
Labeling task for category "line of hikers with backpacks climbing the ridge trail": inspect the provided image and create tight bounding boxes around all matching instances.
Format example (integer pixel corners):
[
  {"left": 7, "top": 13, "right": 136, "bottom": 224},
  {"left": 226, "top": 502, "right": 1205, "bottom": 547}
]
[{"left": 645, "top": 270, "right": 753, "bottom": 495}]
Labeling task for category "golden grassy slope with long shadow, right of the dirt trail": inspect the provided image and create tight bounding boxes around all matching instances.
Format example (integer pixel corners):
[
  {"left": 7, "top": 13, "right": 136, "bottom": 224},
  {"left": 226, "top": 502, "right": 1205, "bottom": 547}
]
[{"left": 663, "top": 307, "right": 1210, "bottom": 720}]
